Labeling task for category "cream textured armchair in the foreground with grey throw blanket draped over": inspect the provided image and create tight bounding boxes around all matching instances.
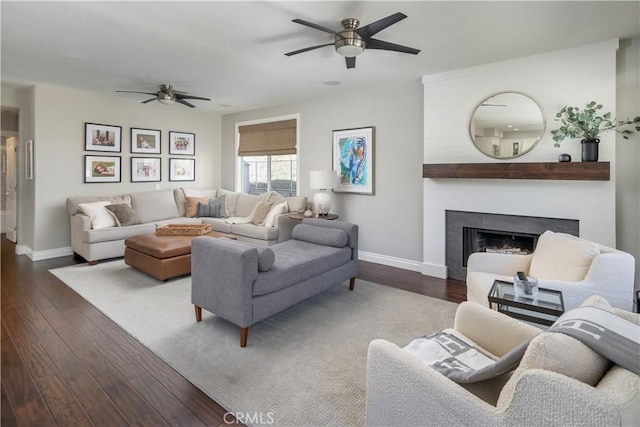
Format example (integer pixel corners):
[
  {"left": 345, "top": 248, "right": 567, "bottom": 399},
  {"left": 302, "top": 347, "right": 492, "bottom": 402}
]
[{"left": 366, "top": 297, "right": 640, "bottom": 427}]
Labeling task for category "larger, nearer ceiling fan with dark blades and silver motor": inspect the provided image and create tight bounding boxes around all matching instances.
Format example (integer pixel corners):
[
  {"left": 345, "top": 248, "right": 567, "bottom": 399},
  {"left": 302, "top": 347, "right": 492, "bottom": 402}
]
[{"left": 285, "top": 12, "right": 420, "bottom": 68}]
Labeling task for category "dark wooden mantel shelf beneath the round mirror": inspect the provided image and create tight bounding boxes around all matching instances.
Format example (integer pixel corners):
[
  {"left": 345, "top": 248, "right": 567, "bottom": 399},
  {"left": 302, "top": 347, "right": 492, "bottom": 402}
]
[{"left": 422, "top": 162, "right": 611, "bottom": 181}]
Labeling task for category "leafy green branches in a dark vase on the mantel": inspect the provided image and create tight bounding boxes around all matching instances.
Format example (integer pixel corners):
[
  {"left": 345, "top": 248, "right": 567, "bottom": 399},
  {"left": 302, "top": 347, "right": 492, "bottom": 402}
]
[{"left": 551, "top": 101, "right": 640, "bottom": 162}]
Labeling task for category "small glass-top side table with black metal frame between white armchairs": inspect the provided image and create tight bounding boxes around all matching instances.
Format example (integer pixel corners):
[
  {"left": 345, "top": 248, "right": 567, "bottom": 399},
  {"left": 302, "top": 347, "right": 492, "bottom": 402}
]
[{"left": 488, "top": 280, "right": 564, "bottom": 326}]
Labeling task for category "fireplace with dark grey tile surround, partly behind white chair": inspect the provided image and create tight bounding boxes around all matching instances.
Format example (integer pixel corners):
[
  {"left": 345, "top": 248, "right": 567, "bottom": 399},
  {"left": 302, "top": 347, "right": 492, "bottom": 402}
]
[{"left": 445, "top": 210, "right": 580, "bottom": 280}]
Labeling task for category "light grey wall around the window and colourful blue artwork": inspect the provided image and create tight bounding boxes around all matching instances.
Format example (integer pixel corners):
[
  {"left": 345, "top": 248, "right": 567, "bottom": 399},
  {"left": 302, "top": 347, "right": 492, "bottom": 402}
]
[{"left": 222, "top": 80, "right": 422, "bottom": 271}]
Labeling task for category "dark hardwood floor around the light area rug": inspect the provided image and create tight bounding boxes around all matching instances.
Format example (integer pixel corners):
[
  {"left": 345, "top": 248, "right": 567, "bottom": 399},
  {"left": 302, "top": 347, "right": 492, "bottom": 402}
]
[{"left": 0, "top": 235, "right": 466, "bottom": 427}]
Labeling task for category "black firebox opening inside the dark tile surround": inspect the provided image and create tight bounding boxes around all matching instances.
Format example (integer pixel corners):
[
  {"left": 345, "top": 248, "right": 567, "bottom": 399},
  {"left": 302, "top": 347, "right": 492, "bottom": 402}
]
[{"left": 462, "top": 227, "right": 539, "bottom": 268}]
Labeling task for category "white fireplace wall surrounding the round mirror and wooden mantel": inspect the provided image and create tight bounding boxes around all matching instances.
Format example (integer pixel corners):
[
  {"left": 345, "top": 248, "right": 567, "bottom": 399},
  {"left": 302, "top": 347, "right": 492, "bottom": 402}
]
[{"left": 422, "top": 40, "right": 618, "bottom": 278}]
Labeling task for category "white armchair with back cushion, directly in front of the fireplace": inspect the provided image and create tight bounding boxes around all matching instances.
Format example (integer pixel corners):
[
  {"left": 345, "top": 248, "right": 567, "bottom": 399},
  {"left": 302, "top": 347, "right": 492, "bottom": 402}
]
[{"left": 467, "top": 231, "right": 635, "bottom": 311}]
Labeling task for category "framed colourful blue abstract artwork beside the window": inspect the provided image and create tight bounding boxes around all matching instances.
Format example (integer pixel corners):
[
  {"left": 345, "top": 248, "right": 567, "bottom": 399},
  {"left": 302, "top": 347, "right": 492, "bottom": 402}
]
[{"left": 333, "top": 126, "right": 375, "bottom": 194}]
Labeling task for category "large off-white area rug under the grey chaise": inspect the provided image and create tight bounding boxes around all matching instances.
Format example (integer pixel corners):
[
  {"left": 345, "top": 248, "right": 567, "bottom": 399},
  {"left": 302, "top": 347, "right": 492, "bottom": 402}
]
[{"left": 51, "top": 260, "right": 457, "bottom": 427}]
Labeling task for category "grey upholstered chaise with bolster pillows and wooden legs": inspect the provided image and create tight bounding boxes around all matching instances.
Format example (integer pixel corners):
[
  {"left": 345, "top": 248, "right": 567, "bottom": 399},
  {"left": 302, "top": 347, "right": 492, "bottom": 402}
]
[{"left": 191, "top": 219, "right": 358, "bottom": 347}]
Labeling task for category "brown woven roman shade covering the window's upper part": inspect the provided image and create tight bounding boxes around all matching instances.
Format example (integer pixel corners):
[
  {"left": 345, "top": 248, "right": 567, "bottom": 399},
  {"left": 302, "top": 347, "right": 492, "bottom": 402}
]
[{"left": 238, "top": 119, "right": 296, "bottom": 156}]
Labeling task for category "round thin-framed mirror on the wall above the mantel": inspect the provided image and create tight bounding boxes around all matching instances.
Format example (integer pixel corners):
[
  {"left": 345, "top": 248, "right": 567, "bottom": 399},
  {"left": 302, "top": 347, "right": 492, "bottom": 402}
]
[{"left": 469, "top": 92, "right": 546, "bottom": 159}]
